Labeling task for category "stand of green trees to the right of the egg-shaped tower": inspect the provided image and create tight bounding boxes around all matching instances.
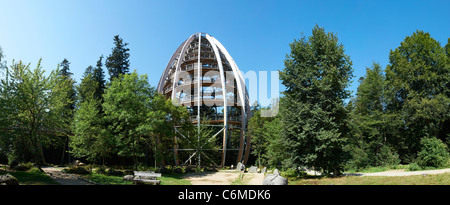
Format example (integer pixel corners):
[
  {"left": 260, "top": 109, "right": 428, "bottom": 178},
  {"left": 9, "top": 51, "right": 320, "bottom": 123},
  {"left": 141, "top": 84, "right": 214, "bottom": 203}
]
[{"left": 249, "top": 26, "right": 450, "bottom": 175}]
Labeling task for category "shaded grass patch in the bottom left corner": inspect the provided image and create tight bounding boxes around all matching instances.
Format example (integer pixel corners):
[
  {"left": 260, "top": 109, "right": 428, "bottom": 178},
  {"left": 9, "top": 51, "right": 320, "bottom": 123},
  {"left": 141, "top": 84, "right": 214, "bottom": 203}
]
[{"left": 0, "top": 171, "right": 58, "bottom": 185}]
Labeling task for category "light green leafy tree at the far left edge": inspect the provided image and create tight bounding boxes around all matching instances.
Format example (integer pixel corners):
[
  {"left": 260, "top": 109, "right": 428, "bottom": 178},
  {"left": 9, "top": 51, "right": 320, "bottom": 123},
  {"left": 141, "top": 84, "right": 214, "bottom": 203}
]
[{"left": 2, "top": 60, "right": 73, "bottom": 166}]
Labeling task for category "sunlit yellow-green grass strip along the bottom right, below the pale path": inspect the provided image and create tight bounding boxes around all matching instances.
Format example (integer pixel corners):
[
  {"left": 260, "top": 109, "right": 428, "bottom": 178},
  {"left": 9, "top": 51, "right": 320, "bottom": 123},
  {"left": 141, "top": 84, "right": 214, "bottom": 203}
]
[{"left": 289, "top": 173, "right": 450, "bottom": 185}]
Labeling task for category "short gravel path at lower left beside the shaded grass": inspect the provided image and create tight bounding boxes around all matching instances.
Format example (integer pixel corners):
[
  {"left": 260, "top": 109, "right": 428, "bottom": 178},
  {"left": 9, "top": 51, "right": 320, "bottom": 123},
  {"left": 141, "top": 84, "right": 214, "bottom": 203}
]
[{"left": 42, "top": 167, "right": 93, "bottom": 185}]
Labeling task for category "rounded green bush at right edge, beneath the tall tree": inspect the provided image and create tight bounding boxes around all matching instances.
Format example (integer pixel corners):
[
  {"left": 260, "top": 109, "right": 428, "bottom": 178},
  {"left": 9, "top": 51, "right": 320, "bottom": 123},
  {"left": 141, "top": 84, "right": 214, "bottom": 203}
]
[{"left": 417, "top": 137, "right": 450, "bottom": 168}]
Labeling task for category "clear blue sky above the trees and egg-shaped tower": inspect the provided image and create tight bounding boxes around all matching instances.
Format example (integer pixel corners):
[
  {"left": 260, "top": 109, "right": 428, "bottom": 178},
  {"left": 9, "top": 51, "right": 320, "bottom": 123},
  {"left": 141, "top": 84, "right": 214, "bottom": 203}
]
[{"left": 0, "top": 0, "right": 450, "bottom": 102}]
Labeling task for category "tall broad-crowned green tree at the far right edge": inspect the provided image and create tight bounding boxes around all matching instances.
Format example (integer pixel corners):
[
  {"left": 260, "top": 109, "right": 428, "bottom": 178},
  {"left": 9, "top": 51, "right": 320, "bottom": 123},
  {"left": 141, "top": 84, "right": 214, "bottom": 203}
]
[{"left": 386, "top": 31, "right": 450, "bottom": 161}]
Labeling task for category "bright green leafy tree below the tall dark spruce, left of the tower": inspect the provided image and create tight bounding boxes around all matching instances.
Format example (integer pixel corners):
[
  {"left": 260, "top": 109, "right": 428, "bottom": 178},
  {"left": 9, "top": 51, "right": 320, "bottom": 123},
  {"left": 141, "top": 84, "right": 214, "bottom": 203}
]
[{"left": 102, "top": 71, "right": 155, "bottom": 166}]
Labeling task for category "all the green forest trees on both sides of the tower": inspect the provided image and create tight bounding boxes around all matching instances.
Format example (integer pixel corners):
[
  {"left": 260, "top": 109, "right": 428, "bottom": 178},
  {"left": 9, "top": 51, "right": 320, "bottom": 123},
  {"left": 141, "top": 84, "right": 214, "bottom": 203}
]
[{"left": 0, "top": 26, "right": 450, "bottom": 175}]
